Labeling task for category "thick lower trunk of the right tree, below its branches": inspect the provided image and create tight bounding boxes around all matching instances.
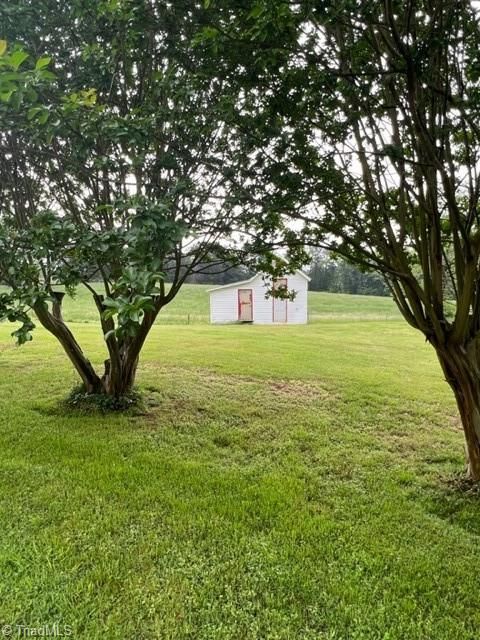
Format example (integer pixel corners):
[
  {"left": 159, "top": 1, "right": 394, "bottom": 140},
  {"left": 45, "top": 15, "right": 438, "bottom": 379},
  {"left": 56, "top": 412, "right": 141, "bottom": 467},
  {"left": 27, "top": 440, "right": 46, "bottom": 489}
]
[{"left": 437, "top": 341, "right": 480, "bottom": 482}]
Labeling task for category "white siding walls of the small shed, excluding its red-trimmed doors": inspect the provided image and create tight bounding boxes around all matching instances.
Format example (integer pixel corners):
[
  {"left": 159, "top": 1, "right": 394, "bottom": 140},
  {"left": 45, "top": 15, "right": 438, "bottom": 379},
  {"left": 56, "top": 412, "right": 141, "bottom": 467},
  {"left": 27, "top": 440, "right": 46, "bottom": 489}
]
[{"left": 210, "top": 272, "right": 308, "bottom": 324}]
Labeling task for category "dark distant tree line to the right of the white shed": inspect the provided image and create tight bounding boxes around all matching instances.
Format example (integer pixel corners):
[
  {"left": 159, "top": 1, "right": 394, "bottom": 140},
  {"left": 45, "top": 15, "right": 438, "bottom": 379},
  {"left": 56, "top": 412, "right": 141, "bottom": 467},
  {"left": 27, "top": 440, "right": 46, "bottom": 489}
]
[{"left": 307, "top": 249, "right": 389, "bottom": 296}]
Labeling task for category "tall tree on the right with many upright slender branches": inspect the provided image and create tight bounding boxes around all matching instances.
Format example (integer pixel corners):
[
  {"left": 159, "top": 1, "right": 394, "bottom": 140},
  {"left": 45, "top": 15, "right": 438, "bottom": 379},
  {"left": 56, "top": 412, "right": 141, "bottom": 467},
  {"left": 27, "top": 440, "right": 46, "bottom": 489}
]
[{"left": 202, "top": 0, "right": 480, "bottom": 481}]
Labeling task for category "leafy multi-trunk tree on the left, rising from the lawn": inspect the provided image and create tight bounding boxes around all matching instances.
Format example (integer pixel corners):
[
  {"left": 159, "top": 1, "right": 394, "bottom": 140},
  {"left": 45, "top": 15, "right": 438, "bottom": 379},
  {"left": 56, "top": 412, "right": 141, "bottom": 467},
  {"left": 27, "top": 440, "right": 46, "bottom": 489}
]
[{"left": 0, "top": 0, "right": 246, "bottom": 396}]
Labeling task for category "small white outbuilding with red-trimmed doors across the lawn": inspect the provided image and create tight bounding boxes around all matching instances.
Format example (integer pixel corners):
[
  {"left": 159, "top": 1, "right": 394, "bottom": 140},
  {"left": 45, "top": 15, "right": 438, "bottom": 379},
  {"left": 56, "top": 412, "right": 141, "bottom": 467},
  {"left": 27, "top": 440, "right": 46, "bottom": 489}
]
[{"left": 209, "top": 271, "right": 310, "bottom": 324}]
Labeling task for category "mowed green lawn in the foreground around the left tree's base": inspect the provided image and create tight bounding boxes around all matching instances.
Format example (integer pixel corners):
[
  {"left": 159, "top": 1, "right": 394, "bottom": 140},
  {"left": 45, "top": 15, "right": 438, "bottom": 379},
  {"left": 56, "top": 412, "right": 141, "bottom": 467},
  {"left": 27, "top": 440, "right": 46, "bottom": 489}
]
[{"left": 0, "top": 298, "right": 480, "bottom": 640}]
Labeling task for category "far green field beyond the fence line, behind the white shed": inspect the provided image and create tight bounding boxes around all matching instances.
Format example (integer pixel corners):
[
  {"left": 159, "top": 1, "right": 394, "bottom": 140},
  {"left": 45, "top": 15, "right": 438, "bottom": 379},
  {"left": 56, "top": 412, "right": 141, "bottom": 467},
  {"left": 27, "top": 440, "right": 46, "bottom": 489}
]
[{"left": 37, "top": 284, "right": 399, "bottom": 324}]
